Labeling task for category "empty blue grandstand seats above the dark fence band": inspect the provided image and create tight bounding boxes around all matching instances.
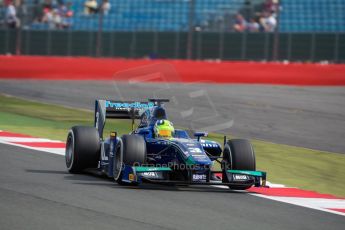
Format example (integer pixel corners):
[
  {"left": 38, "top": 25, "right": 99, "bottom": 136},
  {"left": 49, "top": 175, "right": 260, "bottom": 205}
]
[{"left": 23, "top": 0, "right": 345, "bottom": 32}]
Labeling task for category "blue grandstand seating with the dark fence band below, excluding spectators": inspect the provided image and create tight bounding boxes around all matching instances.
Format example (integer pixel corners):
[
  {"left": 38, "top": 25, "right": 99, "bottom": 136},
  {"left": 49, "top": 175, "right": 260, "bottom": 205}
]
[{"left": 0, "top": 0, "right": 345, "bottom": 62}]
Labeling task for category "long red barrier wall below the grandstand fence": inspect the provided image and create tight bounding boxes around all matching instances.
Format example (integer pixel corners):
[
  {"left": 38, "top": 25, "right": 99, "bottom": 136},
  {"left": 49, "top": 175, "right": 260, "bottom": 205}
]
[{"left": 0, "top": 56, "right": 345, "bottom": 86}]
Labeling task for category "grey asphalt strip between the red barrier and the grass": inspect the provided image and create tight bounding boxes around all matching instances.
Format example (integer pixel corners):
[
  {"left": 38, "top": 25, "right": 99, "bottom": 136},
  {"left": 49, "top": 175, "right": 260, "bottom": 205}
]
[{"left": 0, "top": 80, "right": 345, "bottom": 153}]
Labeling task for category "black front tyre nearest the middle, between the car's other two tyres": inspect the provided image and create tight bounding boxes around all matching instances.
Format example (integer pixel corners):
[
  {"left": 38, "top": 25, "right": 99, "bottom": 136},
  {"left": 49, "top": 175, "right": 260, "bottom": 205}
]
[{"left": 113, "top": 135, "right": 146, "bottom": 184}]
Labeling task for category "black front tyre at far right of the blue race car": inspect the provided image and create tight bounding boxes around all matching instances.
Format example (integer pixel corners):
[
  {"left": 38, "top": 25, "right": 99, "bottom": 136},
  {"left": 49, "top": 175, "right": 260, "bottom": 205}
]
[{"left": 223, "top": 139, "right": 256, "bottom": 190}]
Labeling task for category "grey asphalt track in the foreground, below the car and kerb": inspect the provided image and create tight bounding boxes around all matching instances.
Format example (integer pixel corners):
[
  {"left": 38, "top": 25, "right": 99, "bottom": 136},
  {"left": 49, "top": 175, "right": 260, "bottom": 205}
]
[{"left": 0, "top": 144, "right": 345, "bottom": 230}]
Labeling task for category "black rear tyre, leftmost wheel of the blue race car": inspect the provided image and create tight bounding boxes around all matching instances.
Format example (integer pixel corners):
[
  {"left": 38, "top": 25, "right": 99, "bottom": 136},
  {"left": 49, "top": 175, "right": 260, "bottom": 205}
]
[{"left": 65, "top": 126, "right": 100, "bottom": 173}]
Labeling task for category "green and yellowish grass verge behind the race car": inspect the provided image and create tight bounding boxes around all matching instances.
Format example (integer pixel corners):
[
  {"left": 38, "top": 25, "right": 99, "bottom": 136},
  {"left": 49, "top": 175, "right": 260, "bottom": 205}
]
[{"left": 0, "top": 95, "right": 345, "bottom": 197}]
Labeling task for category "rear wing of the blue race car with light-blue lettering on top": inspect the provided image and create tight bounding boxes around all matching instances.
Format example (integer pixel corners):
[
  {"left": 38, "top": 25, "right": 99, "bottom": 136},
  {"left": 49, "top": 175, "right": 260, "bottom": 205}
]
[{"left": 94, "top": 100, "right": 155, "bottom": 138}]
